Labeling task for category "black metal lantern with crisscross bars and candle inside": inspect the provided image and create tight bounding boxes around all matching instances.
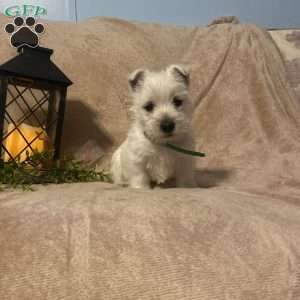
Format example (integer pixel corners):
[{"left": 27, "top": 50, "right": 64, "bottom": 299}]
[{"left": 0, "top": 46, "right": 72, "bottom": 161}]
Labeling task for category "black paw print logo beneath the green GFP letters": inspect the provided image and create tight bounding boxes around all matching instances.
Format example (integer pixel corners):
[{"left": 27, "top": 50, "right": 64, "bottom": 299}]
[{"left": 5, "top": 17, "right": 45, "bottom": 48}]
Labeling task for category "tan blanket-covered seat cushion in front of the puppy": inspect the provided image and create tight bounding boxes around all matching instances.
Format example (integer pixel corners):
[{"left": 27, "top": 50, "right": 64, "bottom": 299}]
[{"left": 0, "top": 183, "right": 300, "bottom": 300}]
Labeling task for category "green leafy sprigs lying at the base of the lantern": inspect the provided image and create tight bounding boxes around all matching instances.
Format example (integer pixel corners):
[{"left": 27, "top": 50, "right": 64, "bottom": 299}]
[{"left": 0, "top": 152, "right": 111, "bottom": 190}]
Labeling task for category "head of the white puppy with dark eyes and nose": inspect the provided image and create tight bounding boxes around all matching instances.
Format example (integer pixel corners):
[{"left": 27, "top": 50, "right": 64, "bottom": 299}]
[{"left": 129, "top": 65, "right": 193, "bottom": 143}]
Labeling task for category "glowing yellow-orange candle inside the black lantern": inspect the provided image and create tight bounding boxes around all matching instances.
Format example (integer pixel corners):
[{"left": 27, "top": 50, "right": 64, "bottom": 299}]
[{"left": 4, "top": 123, "right": 48, "bottom": 162}]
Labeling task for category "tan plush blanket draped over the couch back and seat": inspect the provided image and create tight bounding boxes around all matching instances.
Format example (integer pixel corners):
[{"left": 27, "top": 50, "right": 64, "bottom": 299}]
[{"left": 0, "top": 17, "right": 300, "bottom": 300}]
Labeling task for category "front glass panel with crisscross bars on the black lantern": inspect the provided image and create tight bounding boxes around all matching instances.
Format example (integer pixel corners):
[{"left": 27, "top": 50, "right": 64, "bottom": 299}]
[{"left": 2, "top": 78, "right": 59, "bottom": 161}]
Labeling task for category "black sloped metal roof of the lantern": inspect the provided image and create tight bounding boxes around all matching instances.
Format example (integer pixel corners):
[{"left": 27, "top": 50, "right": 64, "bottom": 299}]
[{"left": 0, "top": 46, "right": 72, "bottom": 86}]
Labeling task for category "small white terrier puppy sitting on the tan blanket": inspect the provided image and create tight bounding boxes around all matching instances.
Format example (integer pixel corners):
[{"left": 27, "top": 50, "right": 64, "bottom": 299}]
[{"left": 111, "top": 65, "right": 196, "bottom": 188}]
